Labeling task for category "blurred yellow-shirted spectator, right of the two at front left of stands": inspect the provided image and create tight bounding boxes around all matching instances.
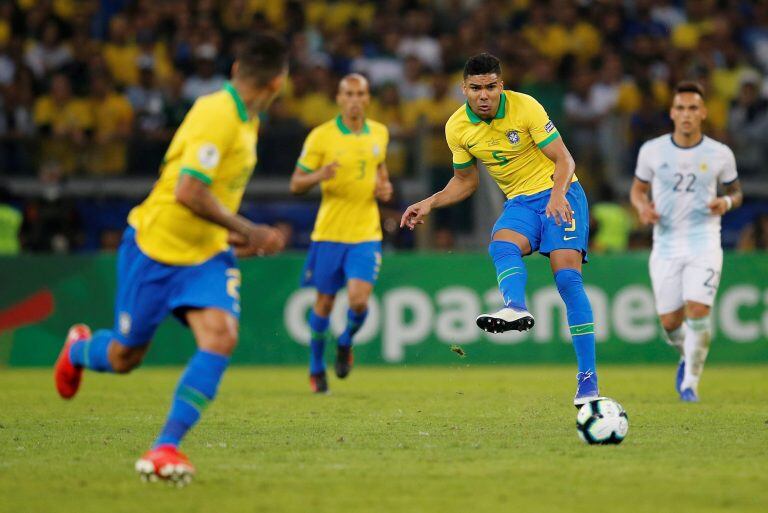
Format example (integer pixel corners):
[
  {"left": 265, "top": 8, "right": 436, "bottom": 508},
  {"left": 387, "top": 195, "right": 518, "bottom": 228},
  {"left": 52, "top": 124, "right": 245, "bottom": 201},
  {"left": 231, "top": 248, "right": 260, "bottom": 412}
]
[{"left": 87, "top": 75, "right": 133, "bottom": 175}]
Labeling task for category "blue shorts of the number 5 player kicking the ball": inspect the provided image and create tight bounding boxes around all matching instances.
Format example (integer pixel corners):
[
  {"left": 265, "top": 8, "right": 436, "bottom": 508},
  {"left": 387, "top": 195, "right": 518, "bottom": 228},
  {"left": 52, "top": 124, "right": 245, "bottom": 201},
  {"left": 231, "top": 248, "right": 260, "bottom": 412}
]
[{"left": 491, "top": 182, "right": 589, "bottom": 262}]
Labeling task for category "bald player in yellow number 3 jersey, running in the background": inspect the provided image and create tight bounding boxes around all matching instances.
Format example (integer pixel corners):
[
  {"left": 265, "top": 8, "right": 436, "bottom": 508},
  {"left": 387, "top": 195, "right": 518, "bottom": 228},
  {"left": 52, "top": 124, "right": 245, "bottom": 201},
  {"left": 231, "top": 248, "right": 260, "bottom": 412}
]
[{"left": 291, "top": 74, "right": 392, "bottom": 393}]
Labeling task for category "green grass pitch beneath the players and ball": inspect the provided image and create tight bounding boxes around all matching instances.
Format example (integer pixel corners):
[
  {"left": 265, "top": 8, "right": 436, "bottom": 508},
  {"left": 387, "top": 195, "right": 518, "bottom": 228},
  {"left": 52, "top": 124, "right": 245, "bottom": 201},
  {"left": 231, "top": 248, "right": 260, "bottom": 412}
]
[{"left": 0, "top": 365, "right": 768, "bottom": 513}]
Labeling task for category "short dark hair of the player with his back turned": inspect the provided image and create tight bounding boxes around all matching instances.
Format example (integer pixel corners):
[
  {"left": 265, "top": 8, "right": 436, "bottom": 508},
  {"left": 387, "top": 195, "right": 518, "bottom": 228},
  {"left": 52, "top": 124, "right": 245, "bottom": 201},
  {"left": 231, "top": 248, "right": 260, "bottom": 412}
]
[{"left": 236, "top": 32, "right": 288, "bottom": 86}]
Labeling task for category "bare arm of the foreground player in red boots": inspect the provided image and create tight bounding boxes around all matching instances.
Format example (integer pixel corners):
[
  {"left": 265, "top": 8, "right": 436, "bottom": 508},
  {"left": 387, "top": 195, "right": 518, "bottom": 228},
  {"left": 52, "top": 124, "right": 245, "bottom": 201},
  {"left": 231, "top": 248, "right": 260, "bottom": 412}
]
[{"left": 176, "top": 175, "right": 285, "bottom": 257}]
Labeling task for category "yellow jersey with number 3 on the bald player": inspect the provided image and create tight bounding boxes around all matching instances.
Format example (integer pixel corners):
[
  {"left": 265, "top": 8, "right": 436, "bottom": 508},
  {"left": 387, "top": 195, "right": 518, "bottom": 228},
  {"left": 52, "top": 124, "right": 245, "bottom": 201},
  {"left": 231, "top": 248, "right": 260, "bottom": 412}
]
[{"left": 296, "top": 116, "right": 389, "bottom": 243}]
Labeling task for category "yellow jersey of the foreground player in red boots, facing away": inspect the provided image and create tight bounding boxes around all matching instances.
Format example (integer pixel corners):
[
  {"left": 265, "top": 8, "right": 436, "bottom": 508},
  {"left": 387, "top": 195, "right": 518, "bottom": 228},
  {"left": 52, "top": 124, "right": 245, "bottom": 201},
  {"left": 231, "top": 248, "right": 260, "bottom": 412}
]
[{"left": 128, "top": 83, "right": 259, "bottom": 265}]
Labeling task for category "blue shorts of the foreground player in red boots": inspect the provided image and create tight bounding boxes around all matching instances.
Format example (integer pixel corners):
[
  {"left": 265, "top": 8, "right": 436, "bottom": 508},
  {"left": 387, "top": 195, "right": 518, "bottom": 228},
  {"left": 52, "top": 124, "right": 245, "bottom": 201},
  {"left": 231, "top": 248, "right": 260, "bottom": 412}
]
[{"left": 114, "top": 227, "right": 240, "bottom": 347}]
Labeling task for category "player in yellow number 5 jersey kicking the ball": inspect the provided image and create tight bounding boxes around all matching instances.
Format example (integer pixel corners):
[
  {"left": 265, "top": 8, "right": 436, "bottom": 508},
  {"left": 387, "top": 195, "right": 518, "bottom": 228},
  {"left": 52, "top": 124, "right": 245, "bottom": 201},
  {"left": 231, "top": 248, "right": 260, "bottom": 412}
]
[{"left": 401, "top": 53, "right": 599, "bottom": 406}]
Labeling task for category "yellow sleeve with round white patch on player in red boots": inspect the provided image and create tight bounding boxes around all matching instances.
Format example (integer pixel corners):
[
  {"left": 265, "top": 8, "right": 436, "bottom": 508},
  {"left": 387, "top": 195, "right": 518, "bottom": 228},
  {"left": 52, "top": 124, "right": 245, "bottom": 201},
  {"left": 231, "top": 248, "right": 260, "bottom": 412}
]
[{"left": 181, "top": 100, "right": 237, "bottom": 185}]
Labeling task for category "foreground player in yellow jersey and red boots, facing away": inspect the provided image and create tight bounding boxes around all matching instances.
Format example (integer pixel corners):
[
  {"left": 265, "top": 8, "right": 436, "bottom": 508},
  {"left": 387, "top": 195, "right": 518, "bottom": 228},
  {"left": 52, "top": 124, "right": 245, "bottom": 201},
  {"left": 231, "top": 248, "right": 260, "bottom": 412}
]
[{"left": 55, "top": 34, "right": 287, "bottom": 484}]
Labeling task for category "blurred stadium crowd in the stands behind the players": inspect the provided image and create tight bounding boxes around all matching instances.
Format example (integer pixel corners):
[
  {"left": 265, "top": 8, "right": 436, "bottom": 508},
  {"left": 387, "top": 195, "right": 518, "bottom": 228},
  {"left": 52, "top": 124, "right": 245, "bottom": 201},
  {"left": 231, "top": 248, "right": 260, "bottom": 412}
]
[{"left": 0, "top": 0, "right": 768, "bottom": 249}]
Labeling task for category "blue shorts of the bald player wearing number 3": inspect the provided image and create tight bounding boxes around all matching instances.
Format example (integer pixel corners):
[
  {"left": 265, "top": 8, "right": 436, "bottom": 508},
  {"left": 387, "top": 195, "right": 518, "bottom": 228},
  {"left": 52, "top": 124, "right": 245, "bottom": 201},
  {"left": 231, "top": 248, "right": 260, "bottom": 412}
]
[{"left": 301, "top": 240, "right": 381, "bottom": 295}]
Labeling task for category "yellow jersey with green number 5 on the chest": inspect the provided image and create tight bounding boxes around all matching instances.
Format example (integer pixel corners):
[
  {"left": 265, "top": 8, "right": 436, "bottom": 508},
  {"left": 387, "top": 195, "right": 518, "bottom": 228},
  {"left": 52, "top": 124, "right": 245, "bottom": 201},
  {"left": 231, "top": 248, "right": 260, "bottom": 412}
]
[{"left": 445, "top": 91, "right": 576, "bottom": 198}]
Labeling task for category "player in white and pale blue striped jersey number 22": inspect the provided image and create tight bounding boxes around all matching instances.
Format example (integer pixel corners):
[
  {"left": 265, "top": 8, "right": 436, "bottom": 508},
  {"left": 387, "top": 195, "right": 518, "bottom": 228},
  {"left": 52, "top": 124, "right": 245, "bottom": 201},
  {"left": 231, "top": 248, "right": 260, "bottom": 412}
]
[{"left": 630, "top": 82, "right": 742, "bottom": 402}]
